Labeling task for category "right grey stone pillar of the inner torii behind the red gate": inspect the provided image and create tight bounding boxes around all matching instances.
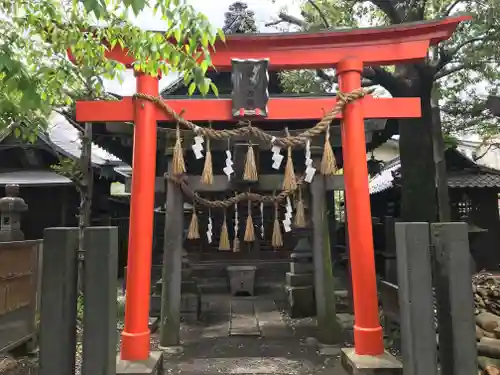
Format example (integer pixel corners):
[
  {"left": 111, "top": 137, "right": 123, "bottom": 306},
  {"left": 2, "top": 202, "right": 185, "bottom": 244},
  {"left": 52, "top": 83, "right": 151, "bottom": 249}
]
[{"left": 310, "top": 173, "right": 342, "bottom": 344}]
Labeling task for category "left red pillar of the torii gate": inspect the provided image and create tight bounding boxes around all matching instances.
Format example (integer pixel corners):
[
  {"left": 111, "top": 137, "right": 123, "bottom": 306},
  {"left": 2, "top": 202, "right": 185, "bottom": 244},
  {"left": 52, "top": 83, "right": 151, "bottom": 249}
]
[{"left": 121, "top": 72, "right": 159, "bottom": 360}]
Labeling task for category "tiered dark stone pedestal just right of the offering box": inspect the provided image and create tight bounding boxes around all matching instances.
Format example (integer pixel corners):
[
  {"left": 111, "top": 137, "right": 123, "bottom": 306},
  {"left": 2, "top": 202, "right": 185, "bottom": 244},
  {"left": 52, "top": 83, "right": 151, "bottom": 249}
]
[{"left": 285, "top": 229, "right": 316, "bottom": 318}]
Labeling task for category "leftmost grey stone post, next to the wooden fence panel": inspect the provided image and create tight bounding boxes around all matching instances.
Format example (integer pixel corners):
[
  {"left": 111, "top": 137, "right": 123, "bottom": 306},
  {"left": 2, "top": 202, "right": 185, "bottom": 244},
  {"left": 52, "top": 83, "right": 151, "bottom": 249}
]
[{"left": 40, "top": 228, "right": 78, "bottom": 375}]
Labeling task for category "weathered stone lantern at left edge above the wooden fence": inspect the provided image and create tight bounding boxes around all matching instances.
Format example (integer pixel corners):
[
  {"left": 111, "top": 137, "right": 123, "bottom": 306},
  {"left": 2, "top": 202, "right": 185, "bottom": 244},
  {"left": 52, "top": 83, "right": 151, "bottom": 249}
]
[{"left": 0, "top": 184, "right": 28, "bottom": 242}]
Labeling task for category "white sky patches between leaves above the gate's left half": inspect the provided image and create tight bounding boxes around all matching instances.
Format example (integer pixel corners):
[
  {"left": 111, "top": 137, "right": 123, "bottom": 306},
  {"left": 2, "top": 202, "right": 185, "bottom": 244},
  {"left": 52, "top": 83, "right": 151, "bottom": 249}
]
[{"left": 104, "top": 0, "right": 300, "bottom": 96}]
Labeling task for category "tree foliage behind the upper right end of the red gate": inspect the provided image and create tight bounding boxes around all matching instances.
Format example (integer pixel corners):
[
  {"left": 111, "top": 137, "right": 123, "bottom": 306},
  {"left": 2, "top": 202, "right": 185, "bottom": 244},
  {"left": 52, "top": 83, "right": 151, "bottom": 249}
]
[{"left": 278, "top": 0, "right": 500, "bottom": 138}]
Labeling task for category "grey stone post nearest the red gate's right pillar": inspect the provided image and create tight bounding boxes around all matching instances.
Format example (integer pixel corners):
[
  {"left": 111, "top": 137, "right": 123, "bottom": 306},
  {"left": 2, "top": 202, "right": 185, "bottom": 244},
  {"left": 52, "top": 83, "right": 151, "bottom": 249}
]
[{"left": 395, "top": 223, "right": 437, "bottom": 375}]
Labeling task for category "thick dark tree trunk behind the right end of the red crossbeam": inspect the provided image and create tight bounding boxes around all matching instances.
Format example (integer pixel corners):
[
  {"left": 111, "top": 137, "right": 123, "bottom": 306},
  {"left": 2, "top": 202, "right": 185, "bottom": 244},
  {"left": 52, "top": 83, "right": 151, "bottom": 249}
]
[{"left": 397, "top": 66, "right": 436, "bottom": 222}]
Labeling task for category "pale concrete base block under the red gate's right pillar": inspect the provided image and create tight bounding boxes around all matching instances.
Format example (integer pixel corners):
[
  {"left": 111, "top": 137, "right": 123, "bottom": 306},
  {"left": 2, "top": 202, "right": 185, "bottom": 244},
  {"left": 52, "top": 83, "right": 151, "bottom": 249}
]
[{"left": 340, "top": 348, "right": 403, "bottom": 375}]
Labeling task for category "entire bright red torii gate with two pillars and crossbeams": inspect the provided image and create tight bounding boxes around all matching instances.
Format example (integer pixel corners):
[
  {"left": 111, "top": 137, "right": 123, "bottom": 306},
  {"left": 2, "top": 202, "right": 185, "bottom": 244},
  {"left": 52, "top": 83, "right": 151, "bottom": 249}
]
[{"left": 70, "top": 16, "right": 470, "bottom": 360}]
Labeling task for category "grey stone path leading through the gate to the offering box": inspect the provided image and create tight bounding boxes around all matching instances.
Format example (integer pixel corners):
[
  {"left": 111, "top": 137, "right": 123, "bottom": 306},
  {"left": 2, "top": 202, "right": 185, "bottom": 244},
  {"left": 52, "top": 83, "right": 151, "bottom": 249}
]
[{"left": 156, "top": 296, "right": 346, "bottom": 375}]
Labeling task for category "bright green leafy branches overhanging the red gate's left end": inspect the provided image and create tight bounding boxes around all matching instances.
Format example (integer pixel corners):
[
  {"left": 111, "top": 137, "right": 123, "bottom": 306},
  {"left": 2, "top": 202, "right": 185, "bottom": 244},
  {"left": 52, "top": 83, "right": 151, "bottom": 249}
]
[{"left": 0, "top": 0, "right": 223, "bottom": 140}]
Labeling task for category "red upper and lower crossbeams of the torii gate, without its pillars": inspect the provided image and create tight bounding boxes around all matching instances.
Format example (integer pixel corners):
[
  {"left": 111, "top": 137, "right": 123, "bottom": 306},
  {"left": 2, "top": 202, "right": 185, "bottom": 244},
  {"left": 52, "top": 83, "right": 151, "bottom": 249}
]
[{"left": 70, "top": 16, "right": 470, "bottom": 122}]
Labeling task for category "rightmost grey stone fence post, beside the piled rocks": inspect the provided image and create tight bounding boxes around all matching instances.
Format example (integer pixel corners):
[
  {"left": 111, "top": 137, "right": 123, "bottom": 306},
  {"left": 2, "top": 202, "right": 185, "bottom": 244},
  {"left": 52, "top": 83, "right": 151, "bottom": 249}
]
[{"left": 431, "top": 223, "right": 477, "bottom": 375}]
